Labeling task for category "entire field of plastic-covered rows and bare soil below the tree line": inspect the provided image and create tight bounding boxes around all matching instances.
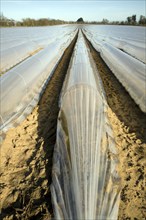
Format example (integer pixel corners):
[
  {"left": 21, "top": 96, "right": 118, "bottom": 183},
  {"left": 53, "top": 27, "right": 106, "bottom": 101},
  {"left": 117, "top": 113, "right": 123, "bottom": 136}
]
[{"left": 0, "top": 24, "right": 146, "bottom": 220}]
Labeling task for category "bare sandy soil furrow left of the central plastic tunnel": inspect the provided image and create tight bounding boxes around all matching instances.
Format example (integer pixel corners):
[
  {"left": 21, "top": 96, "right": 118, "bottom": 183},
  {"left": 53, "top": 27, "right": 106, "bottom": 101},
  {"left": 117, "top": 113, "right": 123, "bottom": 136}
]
[{"left": 0, "top": 34, "right": 78, "bottom": 220}]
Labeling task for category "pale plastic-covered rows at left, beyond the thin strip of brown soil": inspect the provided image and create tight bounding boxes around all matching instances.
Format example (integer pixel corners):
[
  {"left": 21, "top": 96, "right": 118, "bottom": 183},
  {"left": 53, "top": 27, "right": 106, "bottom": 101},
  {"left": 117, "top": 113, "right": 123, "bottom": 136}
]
[{"left": 0, "top": 25, "right": 76, "bottom": 73}]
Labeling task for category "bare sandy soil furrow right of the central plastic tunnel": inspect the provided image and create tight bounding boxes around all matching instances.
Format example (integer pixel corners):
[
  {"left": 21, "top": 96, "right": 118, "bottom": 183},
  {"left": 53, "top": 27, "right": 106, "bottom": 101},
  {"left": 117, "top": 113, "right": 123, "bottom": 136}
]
[{"left": 85, "top": 37, "right": 146, "bottom": 220}]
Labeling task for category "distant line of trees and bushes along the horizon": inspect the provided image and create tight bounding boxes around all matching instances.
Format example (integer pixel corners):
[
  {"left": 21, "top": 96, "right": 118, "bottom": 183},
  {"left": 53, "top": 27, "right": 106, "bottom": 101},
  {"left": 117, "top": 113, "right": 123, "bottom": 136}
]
[{"left": 0, "top": 14, "right": 146, "bottom": 27}]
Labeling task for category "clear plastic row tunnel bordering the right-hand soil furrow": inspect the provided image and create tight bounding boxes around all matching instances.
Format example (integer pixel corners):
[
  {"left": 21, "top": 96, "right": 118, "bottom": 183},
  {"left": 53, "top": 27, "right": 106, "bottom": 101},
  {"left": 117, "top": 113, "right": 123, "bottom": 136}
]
[{"left": 84, "top": 28, "right": 146, "bottom": 112}]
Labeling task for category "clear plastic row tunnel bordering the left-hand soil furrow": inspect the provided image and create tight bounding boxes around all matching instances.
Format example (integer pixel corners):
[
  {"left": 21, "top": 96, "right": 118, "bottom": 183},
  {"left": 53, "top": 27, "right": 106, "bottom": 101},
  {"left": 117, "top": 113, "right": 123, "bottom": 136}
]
[{"left": 0, "top": 28, "right": 77, "bottom": 132}]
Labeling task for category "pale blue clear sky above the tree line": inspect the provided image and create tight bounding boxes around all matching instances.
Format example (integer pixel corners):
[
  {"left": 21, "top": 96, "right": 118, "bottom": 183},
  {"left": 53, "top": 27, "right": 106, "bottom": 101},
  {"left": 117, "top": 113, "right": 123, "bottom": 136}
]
[{"left": 0, "top": 0, "right": 146, "bottom": 21}]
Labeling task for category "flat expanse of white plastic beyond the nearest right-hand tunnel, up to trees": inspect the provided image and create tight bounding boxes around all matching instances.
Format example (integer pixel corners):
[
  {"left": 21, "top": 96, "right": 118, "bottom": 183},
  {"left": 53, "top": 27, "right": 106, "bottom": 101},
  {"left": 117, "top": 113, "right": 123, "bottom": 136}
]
[{"left": 84, "top": 25, "right": 146, "bottom": 63}]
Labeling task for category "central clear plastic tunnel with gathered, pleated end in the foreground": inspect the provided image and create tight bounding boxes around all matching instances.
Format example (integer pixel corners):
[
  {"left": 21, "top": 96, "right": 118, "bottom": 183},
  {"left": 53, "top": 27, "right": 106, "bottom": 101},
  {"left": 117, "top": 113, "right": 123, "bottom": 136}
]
[{"left": 51, "top": 33, "right": 120, "bottom": 220}]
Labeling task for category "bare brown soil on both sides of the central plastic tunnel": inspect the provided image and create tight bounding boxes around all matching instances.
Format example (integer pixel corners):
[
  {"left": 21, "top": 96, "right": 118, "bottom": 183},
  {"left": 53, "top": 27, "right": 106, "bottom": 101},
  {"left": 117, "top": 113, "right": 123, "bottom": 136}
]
[{"left": 0, "top": 33, "right": 146, "bottom": 220}]
